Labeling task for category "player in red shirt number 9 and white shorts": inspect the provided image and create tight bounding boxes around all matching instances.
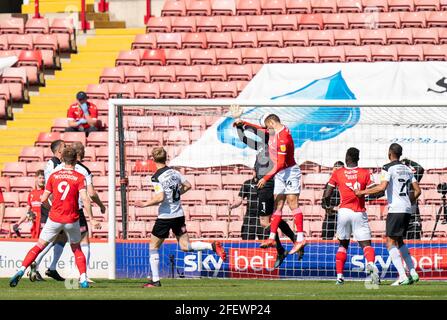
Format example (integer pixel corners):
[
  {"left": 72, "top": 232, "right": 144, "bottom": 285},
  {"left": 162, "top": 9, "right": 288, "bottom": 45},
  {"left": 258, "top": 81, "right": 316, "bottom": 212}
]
[{"left": 9, "top": 148, "right": 98, "bottom": 288}]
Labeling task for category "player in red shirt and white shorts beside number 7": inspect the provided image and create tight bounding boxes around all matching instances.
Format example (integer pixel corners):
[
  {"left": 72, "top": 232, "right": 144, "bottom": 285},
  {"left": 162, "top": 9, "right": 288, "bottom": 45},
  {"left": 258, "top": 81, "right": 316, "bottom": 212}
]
[{"left": 323, "top": 148, "right": 380, "bottom": 284}]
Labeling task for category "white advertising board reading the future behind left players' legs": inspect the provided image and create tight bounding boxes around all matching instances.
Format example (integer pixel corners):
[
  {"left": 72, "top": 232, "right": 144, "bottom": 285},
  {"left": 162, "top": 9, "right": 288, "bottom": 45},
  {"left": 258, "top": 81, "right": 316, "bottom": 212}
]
[{"left": 0, "top": 241, "right": 108, "bottom": 279}]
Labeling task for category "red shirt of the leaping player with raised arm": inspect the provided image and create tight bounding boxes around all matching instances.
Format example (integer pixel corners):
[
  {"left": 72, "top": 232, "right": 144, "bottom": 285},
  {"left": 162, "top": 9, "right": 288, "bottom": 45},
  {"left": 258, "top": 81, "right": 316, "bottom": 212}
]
[{"left": 242, "top": 121, "right": 296, "bottom": 181}]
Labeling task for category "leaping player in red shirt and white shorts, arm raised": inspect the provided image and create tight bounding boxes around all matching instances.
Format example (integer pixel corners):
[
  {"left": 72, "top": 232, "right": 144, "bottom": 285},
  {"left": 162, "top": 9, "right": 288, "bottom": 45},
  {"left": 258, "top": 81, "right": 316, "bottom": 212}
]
[{"left": 235, "top": 114, "right": 306, "bottom": 254}]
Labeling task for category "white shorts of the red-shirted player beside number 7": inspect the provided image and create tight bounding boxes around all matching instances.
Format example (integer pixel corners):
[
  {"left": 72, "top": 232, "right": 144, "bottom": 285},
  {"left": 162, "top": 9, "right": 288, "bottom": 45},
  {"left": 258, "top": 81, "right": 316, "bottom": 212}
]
[{"left": 337, "top": 208, "right": 371, "bottom": 241}]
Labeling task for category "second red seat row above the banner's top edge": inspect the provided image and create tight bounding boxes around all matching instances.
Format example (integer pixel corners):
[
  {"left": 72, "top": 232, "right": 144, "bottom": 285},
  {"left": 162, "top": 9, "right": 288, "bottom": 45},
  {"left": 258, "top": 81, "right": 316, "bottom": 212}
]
[{"left": 136, "top": 28, "right": 447, "bottom": 50}]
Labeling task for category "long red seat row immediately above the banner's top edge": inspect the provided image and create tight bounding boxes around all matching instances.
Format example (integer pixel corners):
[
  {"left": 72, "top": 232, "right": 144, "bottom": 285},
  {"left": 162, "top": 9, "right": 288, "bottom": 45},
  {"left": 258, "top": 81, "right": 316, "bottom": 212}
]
[{"left": 116, "top": 44, "right": 446, "bottom": 69}]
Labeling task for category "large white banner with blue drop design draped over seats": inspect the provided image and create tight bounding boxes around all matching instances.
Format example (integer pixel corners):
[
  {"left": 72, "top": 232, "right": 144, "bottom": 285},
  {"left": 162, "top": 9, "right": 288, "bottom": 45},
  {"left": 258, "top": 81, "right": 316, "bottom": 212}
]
[{"left": 171, "top": 62, "right": 447, "bottom": 168}]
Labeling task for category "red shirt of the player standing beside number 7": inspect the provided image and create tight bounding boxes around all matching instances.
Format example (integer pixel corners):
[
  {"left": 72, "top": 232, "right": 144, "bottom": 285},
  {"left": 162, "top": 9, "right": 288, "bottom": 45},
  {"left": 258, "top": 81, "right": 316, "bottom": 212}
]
[{"left": 328, "top": 167, "right": 374, "bottom": 212}]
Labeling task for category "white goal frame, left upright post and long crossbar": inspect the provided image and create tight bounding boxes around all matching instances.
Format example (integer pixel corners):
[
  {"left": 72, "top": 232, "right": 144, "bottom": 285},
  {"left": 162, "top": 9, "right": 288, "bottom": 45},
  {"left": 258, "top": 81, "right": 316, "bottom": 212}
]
[{"left": 108, "top": 98, "right": 447, "bottom": 279}]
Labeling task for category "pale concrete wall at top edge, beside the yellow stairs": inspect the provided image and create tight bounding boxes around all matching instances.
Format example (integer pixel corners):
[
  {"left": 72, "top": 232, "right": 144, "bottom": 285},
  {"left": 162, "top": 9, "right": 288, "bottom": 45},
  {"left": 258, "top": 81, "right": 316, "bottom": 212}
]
[{"left": 105, "top": 0, "right": 164, "bottom": 28}]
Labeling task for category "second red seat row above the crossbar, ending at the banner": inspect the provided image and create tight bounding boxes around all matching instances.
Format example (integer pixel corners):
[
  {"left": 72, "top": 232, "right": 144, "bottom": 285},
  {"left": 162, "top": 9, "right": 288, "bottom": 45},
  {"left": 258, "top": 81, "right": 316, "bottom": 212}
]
[{"left": 99, "top": 64, "right": 262, "bottom": 83}]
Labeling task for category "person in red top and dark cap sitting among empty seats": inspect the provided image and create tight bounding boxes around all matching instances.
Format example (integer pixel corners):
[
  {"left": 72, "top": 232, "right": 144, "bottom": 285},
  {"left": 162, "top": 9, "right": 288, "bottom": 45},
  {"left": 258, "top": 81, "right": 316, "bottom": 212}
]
[{"left": 65, "top": 91, "right": 98, "bottom": 135}]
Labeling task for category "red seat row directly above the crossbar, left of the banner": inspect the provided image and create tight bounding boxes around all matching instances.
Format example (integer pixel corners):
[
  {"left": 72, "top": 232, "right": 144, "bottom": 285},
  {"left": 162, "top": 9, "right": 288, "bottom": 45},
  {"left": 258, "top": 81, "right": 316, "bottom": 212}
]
[{"left": 86, "top": 81, "right": 247, "bottom": 99}]
